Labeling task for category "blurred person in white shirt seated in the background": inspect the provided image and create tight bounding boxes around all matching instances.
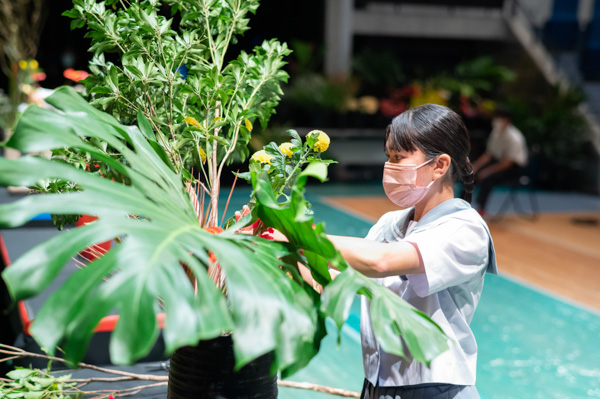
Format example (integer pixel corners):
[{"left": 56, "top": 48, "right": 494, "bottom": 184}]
[{"left": 473, "top": 108, "right": 528, "bottom": 216}]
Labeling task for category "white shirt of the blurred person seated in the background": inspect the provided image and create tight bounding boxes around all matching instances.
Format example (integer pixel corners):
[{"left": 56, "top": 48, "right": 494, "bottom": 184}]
[{"left": 486, "top": 125, "right": 527, "bottom": 167}]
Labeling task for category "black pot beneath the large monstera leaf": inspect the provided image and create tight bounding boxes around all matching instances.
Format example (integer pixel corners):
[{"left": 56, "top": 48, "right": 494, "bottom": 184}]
[{"left": 167, "top": 336, "right": 277, "bottom": 399}]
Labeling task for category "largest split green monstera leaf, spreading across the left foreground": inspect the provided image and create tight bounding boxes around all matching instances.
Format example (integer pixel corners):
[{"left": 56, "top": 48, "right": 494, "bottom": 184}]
[{"left": 0, "top": 89, "right": 321, "bottom": 376}]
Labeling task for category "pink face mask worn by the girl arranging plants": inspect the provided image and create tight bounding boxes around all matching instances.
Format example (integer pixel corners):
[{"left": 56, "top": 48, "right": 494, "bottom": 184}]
[{"left": 383, "top": 158, "right": 435, "bottom": 208}]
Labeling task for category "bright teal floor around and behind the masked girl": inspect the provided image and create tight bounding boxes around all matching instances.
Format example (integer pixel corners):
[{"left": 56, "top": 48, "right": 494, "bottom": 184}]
[{"left": 221, "top": 184, "right": 600, "bottom": 399}]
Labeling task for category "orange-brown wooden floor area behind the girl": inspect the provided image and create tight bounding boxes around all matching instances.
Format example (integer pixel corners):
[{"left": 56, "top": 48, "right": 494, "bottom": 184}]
[{"left": 325, "top": 197, "right": 600, "bottom": 310}]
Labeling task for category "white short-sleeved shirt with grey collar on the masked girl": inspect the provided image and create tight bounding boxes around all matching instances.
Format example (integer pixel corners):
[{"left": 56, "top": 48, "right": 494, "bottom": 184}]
[{"left": 361, "top": 199, "right": 496, "bottom": 386}]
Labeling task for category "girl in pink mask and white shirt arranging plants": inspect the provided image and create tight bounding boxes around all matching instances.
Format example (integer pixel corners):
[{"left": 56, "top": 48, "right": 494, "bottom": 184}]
[{"left": 330, "top": 104, "right": 496, "bottom": 399}]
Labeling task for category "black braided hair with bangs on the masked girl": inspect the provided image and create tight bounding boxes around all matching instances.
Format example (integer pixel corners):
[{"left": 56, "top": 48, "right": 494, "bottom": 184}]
[{"left": 384, "top": 104, "right": 475, "bottom": 202}]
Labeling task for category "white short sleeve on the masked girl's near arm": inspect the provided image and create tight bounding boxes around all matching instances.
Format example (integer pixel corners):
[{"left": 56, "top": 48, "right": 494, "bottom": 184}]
[{"left": 406, "top": 218, "right": 490, "bottom": 297}]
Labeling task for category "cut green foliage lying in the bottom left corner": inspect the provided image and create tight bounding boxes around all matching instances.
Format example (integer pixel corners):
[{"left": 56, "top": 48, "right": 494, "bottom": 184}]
[{"left": 0, "top": 367, "right": 78, "bottom": 399}]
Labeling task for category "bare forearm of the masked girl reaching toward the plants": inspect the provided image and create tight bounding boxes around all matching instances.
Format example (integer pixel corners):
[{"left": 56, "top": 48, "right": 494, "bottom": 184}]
[{"left": 327, "top": 235, "right": 425, "bottom": 277}]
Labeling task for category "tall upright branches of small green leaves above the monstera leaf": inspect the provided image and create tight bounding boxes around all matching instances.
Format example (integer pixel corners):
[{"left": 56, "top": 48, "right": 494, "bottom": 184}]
[{"left": 64, "top": 0, "right": 290, "bottom": 173}]
